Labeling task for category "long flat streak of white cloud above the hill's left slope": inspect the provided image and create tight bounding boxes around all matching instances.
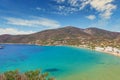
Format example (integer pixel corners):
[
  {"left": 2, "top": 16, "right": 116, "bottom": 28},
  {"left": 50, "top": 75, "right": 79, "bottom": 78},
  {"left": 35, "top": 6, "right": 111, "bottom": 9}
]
[{"left": 4, "top": 17, "right": 60, "bottom": 28}]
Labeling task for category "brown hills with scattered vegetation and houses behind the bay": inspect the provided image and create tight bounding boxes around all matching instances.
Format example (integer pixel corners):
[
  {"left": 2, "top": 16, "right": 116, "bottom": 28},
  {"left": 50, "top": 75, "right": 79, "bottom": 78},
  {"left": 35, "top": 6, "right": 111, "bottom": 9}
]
[{"left": 0, "top": 26, "right": 120, "bottom": 45}]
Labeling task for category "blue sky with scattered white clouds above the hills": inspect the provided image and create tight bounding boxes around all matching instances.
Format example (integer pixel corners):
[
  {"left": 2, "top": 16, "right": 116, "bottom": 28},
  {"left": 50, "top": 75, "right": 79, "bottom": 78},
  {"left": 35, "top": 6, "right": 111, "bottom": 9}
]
[{"left": 0, "top": 0, "right": 120, "bottom": 35}]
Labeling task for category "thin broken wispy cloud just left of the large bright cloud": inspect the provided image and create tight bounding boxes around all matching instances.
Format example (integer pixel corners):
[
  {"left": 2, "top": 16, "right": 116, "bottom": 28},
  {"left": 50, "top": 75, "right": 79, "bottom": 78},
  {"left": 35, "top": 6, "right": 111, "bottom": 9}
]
[{"left": 53, "top": 0, "right": 80, "bottom": 15}]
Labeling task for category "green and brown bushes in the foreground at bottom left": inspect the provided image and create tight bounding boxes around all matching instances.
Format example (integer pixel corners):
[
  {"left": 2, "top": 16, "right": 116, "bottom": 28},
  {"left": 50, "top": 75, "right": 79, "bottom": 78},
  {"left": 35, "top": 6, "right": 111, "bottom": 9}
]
[{"left": 0, "top": 70, "right": 55, "bottom": 80}]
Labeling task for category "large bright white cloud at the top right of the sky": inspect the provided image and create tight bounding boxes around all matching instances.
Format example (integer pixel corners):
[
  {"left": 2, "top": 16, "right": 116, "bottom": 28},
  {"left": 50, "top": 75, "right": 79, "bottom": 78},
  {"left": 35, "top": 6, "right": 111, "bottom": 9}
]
[{"left": 80, "top": 0, "right": 117, "bottom": 19}]
